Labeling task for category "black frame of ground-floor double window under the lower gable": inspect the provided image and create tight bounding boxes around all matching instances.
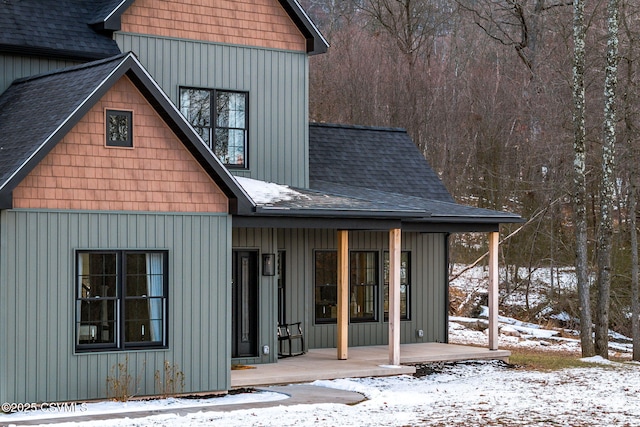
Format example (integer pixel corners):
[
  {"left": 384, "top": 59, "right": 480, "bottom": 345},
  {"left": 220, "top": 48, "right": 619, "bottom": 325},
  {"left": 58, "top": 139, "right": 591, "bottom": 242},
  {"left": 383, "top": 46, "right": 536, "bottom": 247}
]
[{"left": 73, "top": 249, "right": 170, "bottom": 354}]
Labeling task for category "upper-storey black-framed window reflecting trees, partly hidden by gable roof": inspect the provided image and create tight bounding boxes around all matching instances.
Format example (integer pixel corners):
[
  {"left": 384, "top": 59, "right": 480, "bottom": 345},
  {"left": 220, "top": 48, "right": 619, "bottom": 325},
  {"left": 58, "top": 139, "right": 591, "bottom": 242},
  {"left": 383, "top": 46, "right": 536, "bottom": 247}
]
[{"left": 180, "top": 88, "right": 249, "bottom": 168}]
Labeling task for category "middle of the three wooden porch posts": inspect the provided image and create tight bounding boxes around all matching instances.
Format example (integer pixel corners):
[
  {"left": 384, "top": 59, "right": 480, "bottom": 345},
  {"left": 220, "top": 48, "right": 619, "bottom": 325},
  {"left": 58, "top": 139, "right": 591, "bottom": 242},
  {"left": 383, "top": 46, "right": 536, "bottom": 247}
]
[{"left": 389, "top": 228, "right": 401, "bottom": 365}]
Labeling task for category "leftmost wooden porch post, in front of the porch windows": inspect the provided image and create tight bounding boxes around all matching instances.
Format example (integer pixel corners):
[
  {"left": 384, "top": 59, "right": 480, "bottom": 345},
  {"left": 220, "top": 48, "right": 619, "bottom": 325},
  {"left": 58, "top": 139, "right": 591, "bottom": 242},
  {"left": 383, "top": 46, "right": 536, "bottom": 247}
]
[{"left": 338, "top": 230, "right": 349, "bottom": 360}]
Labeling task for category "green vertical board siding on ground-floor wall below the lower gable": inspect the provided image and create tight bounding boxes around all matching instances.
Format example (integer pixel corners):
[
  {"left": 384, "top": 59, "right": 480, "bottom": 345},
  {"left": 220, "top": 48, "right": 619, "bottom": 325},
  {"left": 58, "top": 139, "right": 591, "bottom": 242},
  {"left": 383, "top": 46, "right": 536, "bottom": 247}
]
[{"left": 0, "top": 210, "right": 231, "bottom": 402}]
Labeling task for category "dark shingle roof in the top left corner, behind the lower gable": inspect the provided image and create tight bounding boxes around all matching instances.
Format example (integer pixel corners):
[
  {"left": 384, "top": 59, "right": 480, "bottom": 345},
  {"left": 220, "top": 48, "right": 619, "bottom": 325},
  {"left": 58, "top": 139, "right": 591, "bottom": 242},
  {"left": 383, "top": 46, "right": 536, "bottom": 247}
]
[{"left": 0, "top": 0, "right": 120, "bottom": 60}]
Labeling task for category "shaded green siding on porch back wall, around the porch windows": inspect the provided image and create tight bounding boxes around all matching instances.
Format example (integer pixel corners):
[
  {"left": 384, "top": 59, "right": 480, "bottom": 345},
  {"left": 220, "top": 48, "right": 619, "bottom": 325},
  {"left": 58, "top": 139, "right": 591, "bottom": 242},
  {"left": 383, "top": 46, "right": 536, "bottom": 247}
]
[{"left": 279, "top": 229, "right": 448, "bottom": 348}]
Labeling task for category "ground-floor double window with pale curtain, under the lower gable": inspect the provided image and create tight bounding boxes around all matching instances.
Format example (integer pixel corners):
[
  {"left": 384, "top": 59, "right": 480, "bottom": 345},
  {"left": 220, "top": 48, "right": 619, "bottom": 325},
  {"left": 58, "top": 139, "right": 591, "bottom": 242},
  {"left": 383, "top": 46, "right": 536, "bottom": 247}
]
[{"left": 75, "top": 250, "right": 168, "bottom": 352}]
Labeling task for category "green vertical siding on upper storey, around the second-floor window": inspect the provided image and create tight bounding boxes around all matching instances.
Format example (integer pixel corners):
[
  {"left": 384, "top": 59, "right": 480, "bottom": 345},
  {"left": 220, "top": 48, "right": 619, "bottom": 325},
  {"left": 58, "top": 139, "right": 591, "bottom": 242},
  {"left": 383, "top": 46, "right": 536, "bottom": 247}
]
[{"left": 115, "top": 32, "right": 309, "bottom": 188}]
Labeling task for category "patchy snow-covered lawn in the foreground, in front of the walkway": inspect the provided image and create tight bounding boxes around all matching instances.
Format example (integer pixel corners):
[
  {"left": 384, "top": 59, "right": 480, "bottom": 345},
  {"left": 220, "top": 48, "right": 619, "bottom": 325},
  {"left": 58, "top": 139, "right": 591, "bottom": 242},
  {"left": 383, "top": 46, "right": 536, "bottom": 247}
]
[{"left": 0, "top": 359, "right": 640, "bottom": 427}]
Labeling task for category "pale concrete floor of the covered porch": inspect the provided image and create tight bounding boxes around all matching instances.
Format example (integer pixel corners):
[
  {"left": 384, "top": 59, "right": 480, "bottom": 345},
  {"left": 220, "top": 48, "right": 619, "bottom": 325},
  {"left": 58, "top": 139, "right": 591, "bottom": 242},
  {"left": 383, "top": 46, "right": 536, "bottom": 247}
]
[{"left": 231, "top": 343, "right": 511, "bottom": 388}]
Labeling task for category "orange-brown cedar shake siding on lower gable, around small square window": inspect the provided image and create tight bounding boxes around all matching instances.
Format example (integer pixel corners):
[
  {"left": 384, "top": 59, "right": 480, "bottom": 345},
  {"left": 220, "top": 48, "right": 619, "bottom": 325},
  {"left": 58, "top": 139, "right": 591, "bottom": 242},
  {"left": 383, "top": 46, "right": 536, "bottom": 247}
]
[{"left": 13, "top": 77, "right": 228, "bottom": 213}]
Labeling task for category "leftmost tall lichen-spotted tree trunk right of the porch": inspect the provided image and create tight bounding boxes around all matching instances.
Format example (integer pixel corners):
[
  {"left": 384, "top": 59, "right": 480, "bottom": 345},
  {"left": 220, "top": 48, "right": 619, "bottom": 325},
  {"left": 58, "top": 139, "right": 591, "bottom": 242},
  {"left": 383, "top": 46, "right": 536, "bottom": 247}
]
[{"left": 573, "top": 0, "right": 595, "bottom": 357}]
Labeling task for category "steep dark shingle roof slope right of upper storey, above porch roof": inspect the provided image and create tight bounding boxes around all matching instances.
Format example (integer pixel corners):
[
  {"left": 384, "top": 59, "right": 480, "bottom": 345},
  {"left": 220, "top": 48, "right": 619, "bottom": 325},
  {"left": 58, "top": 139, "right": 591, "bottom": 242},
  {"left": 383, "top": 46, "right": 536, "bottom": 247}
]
[{"left": 309, "top": 123, "right": 453, "bottom": 202}]
